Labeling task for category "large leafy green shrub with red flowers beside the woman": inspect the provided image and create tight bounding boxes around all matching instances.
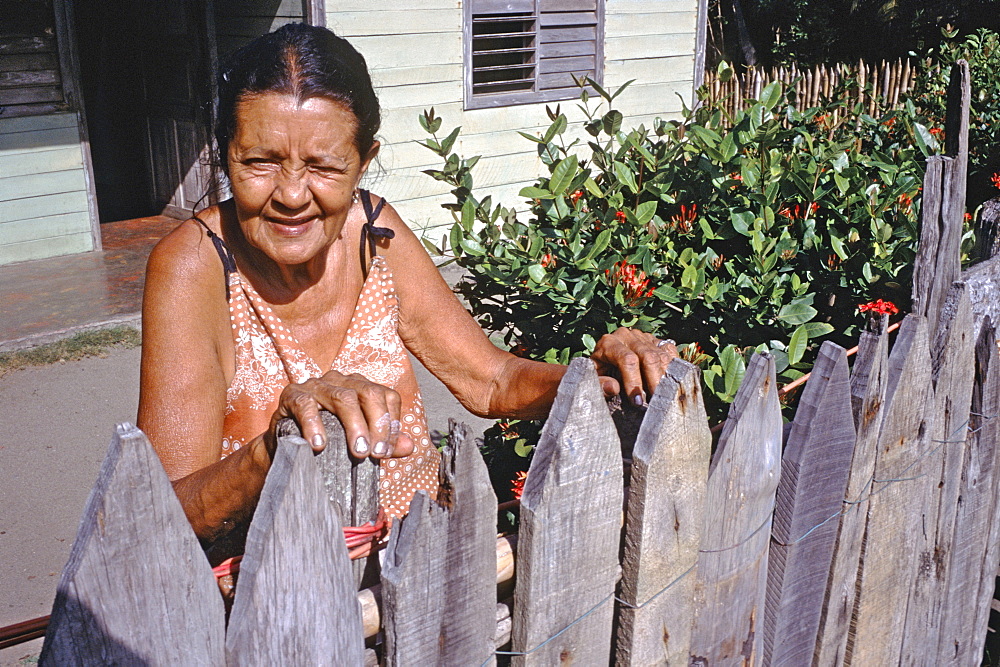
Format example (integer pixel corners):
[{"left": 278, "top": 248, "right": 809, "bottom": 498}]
[{"left": 421, "top": 70, "right": 937, "bottom": 482}]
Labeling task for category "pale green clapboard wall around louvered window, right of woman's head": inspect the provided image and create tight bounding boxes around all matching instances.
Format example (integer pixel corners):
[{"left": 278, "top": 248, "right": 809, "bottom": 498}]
[{"left": 326, "top": 0, "right": 698, "bottom": 241}]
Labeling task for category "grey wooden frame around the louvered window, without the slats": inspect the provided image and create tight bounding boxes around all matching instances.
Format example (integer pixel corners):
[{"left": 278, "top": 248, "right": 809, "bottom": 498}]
[{"left": 462, "top": 0, "right": 605, "bottom": 110}]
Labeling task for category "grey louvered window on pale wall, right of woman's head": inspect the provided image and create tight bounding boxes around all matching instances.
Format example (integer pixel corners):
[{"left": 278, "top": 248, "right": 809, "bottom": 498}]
[{"left": 465, "top": 0, "right": 604, "bottom": 109}]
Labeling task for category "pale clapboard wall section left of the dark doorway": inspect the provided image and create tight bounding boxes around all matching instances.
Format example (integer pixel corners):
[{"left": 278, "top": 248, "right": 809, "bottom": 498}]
[{"left": 0, "top": 113, "right": 94, "bottom": 264}]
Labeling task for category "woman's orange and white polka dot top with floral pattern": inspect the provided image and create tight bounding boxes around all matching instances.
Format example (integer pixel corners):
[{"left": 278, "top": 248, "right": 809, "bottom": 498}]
[{"left": 222, "top": 248, "right": 440, "bottom": 517}]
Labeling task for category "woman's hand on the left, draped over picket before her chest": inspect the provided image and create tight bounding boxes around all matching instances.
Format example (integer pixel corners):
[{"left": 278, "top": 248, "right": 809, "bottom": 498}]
[{"left": 264, "top": 371, "right": 413, "bottom": 459}]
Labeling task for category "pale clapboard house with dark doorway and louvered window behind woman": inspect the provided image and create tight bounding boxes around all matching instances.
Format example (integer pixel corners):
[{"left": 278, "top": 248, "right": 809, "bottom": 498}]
[{"left": 0, "top": 0, "right": 707, "bottom": 264}]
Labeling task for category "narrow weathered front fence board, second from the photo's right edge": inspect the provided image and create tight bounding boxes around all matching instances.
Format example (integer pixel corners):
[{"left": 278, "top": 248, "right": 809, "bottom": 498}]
[{"left": 902, "top": 283, "right": 975, "bottom": 664}]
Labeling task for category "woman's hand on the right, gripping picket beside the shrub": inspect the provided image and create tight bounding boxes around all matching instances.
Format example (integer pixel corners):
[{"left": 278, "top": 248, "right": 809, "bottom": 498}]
[{"left": 591, "top": 327, "right": 677, "bottom": 405}]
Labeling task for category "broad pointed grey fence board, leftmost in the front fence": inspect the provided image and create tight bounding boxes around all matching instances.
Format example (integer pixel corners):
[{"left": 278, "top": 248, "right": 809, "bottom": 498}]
[{"left": 40, "top": 424, "right": 225, "bottom": 666}]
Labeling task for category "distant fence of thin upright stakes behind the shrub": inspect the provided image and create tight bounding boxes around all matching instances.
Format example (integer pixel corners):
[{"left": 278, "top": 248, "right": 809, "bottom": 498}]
[{"left": 705, "top": 59, "right": 917, "bottom": 114}]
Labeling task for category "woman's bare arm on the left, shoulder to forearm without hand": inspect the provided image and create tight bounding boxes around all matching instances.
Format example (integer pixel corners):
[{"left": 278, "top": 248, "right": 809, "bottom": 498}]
[{"left": 137, "top": 221, "right": 270, "bottom": 542}]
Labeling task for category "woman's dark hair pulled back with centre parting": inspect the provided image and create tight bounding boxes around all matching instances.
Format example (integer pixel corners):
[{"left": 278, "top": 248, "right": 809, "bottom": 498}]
[{"left": 215, "top": 23, "right": 382, "bottom": 174}]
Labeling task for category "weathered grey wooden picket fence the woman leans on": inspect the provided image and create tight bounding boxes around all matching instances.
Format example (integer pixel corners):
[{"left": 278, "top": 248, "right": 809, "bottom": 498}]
[{"left": 33, "top": 60, "right": 1000, "bottom": 666}]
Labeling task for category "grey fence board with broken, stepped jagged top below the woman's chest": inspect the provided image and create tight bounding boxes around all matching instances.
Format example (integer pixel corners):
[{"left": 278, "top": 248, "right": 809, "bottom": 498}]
[{"left": 382, "top": 423, "right": 497, "bottom": 665}]
